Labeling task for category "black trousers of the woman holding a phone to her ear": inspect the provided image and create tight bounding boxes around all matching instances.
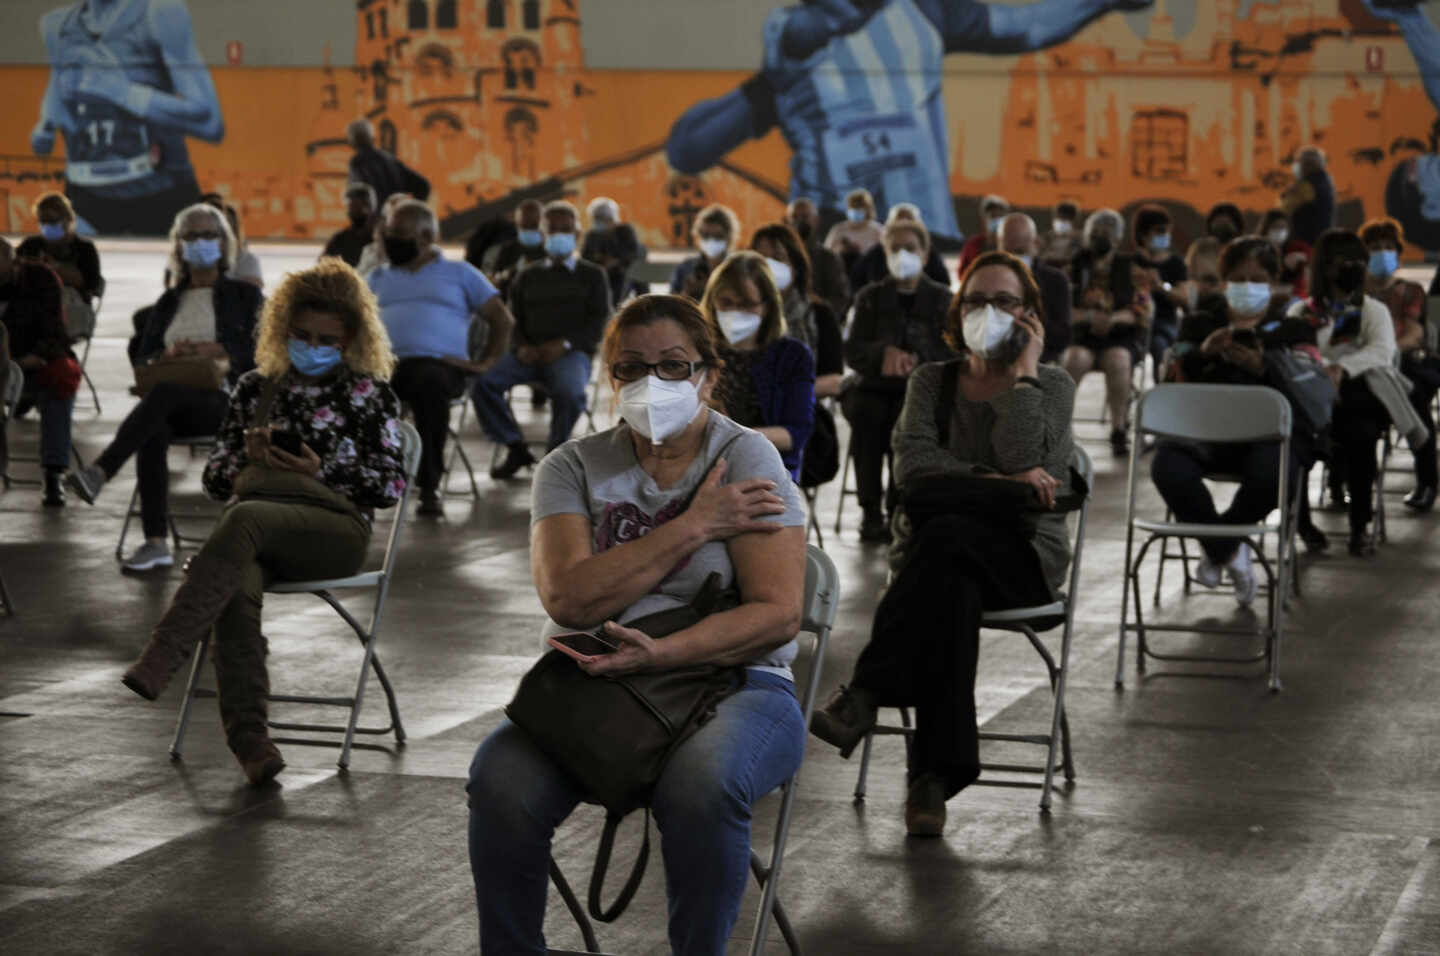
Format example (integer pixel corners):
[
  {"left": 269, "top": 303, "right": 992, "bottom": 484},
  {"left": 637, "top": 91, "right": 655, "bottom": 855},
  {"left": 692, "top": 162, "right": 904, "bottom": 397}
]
[{"left": 851, "top": 513, "right": 1054, "bottom": 798}]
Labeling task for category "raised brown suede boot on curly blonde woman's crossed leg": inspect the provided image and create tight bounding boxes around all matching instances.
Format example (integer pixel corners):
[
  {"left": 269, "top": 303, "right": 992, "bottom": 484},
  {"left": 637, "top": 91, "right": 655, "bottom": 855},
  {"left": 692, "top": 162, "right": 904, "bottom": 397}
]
[{"left": 121, "top": 551, "right": 242, "bottom": 700}]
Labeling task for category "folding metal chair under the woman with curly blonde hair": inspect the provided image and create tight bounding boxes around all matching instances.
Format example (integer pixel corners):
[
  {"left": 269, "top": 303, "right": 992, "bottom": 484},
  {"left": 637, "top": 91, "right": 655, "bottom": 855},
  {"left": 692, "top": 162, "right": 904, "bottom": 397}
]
[{"left": 170, "top": 422, "right": 420, "bottom": 770}]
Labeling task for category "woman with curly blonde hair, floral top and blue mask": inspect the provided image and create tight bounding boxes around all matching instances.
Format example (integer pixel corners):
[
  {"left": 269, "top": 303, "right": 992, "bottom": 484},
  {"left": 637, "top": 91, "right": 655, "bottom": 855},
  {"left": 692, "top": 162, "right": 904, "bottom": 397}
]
[{"left": 122, "top": 259, "right": 405, "bottom": 785}]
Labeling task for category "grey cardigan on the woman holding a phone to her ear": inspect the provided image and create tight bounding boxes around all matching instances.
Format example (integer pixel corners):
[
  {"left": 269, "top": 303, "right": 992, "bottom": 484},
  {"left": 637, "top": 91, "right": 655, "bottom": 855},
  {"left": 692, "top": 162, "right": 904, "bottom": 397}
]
[{"left": 890, "top": 363, "right": 1076, "bottom": 590}]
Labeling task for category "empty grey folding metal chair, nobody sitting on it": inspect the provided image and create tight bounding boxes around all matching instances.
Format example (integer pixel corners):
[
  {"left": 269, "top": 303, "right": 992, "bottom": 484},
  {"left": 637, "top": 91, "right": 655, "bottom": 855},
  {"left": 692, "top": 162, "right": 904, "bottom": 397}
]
[{"left": 1115, "top": 384, "right": 1295, "bottom": 691}]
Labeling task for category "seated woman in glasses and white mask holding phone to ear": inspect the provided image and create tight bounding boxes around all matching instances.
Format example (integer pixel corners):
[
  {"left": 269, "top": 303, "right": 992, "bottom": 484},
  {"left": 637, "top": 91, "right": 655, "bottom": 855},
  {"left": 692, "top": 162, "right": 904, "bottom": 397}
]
[{"left": 811, "top": 252, "right": 1076, "bottom": 837}]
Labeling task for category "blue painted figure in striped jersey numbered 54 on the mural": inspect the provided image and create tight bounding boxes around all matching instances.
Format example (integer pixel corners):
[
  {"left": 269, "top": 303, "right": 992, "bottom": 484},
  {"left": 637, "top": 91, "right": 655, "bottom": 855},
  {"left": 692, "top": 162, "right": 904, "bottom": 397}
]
[{"left": 667, "top": 0, "right": 1153, "bottom": 238}]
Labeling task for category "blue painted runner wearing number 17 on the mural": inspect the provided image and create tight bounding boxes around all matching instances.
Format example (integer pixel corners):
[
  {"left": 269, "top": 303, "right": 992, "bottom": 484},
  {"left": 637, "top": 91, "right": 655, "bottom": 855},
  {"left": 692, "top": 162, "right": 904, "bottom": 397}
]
[{"left": 30, "top": 0, "right": 225, "bottom": 235}]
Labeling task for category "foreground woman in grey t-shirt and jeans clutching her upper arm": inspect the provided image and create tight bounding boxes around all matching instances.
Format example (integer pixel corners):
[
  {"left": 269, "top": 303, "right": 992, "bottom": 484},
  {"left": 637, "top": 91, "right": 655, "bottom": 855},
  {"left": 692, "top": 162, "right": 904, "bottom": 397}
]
[{"left": 467, "top": 295, "right": 805, "bottom": 953}]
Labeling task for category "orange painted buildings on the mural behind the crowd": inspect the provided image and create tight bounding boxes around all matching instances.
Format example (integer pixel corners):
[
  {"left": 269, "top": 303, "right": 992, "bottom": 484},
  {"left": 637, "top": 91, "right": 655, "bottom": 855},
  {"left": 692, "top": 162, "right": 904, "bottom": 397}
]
[{"left": 0, "top": 0, "right": 1440, "bottom": 246}]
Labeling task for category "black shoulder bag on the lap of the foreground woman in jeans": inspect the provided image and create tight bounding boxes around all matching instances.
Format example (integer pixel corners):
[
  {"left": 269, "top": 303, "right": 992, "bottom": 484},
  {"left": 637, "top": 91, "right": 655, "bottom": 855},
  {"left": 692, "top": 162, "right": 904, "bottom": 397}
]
[{"left": 505, "top": 439, "right": 746, "bottom": 923}]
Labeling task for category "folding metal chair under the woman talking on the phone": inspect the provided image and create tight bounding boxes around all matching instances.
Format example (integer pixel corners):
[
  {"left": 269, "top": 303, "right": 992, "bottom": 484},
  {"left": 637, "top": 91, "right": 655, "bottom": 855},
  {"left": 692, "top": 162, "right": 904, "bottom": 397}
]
[{"left": 855, "top": 445, "right": 1094, "bottom": 813}]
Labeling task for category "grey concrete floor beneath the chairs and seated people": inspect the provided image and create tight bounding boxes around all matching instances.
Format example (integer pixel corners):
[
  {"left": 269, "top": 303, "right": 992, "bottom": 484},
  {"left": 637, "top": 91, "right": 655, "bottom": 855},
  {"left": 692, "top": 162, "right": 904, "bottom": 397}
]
[{"left": 0, "top": 242, "right": 1440, "bottom": 955}]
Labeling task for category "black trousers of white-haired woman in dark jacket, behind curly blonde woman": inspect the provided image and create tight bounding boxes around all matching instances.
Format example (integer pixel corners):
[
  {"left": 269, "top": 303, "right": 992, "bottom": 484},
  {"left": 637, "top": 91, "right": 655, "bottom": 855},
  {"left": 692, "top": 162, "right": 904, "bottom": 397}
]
[{"left": 95, "top": 384, "right": 229, "bottom": 538}]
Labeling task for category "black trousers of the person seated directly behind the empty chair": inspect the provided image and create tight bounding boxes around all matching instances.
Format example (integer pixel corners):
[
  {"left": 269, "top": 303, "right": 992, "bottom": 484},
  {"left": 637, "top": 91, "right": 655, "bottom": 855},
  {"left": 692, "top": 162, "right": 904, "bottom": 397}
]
[{"left": 1151, "top": 442, "right": 1299, "bottom": 564}]
